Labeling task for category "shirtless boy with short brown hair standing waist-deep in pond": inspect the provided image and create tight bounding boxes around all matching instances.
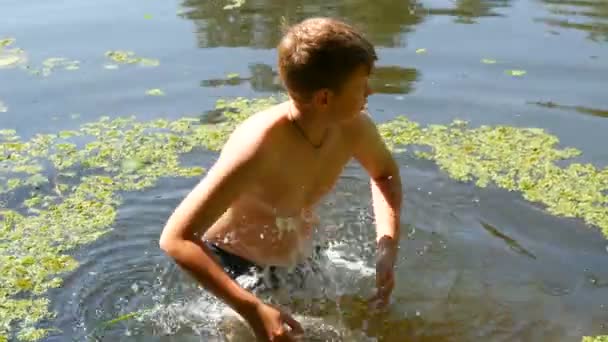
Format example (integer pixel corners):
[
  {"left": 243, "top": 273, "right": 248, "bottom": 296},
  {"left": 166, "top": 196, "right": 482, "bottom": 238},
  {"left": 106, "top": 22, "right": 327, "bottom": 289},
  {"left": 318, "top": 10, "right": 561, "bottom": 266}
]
[{"left": 160, "top": 18, "right": 402, "bottom": 341}]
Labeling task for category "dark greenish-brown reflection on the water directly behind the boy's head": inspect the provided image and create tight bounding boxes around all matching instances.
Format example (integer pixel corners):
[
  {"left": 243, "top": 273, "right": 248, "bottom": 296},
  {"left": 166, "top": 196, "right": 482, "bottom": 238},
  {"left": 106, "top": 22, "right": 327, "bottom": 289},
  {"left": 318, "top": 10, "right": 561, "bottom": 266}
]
[{"left": 182, "top": 0, "right": 423, "bottom": 48}]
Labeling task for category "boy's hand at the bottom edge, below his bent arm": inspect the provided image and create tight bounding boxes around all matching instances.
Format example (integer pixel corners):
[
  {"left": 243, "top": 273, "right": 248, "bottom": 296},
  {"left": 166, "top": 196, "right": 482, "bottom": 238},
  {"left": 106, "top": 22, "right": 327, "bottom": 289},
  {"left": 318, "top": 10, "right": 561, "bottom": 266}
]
[{"left": 243, "top": 302, "right": 304, "bottom": 342}]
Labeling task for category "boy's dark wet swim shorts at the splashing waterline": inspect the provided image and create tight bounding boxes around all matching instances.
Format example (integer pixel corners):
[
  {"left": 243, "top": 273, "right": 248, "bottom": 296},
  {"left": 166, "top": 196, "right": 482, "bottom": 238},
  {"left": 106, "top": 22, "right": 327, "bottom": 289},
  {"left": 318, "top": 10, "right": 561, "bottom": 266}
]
[{"left": 204, "top": 241, "right": 321, "bottom": 290}]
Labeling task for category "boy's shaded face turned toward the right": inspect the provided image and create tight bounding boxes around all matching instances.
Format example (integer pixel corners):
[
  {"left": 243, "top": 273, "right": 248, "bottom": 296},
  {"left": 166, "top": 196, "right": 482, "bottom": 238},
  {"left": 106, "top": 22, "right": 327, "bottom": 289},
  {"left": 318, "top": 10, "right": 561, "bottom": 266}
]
[{"left": 328, "top": 65, "right": 372, "bottom": 122}]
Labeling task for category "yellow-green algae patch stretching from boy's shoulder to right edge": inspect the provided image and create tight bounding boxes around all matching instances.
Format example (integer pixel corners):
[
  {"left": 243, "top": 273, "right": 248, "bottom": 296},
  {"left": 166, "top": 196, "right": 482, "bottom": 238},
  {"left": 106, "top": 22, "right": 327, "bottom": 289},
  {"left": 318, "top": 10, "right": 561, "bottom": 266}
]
[{"left": 379, "top": 117, "right": 608, "bottom": 238}]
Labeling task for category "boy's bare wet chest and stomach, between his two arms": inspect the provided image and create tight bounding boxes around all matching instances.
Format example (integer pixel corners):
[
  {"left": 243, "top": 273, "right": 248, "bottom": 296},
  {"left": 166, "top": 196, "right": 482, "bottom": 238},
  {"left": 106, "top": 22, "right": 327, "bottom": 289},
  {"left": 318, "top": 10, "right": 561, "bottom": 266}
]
[{"left": 204, "top": 99, "right": 369, "bottom": 266}]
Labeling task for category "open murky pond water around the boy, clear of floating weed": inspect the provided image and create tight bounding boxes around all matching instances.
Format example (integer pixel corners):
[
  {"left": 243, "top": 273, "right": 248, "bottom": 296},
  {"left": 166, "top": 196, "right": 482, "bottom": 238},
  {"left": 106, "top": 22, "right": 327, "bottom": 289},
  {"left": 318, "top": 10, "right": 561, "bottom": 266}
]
[{"left": 0, "top": 0, "right": 608, "bottom": 341}]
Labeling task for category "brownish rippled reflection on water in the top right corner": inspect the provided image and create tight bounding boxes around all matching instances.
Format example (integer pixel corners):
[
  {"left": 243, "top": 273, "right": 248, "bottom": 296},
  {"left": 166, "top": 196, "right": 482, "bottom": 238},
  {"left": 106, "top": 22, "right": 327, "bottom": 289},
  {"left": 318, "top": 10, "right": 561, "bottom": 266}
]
[{"left": 537, "top": 0, "right": 608, "bottom": 42}]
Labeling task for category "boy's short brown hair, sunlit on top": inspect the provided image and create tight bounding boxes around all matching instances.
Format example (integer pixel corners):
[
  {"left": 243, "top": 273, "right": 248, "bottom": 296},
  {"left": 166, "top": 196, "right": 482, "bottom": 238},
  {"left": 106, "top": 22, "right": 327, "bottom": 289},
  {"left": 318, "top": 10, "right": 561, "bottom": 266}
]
[{"left": 278, "top": 18, "right": 378, "bottom": 101}]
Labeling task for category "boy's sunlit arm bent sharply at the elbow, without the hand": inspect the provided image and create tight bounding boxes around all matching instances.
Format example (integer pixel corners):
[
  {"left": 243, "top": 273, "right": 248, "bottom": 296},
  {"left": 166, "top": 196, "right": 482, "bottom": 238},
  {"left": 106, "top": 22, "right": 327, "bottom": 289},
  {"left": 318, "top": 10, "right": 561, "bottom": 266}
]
[{"left": 160, "top": 123, "right": 263, "bottom": 314}]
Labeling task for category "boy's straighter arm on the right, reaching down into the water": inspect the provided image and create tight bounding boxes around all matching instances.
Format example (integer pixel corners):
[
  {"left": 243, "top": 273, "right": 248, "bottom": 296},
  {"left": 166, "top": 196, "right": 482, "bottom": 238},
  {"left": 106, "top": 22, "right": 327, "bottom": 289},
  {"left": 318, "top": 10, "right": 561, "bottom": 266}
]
[{"left": 353, "top": 114, "right": 402, "bottom": 307}]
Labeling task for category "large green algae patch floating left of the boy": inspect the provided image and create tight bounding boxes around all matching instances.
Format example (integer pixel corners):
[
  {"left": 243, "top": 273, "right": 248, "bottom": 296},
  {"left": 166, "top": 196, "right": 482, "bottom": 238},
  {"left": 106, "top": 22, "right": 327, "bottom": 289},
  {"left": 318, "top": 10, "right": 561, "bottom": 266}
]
[{"left": 0, "top": 95, "right": 277, "bottom": 341}]
